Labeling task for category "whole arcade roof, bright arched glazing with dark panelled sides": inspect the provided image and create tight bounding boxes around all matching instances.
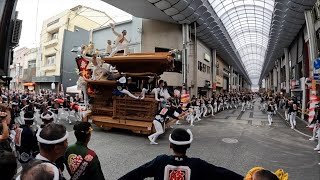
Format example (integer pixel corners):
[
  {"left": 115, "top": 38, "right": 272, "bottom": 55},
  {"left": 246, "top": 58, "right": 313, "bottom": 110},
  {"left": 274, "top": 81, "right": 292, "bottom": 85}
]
[{"left": 104, "top": 0, "right": 316, "bottom": 84}]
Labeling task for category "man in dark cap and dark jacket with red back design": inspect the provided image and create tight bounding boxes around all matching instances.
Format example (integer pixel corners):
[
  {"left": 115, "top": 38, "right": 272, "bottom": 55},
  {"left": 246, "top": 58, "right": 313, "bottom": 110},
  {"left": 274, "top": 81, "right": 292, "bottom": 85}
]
[{"left": 65, "top": 122, "right": 104, "bottom": 180}]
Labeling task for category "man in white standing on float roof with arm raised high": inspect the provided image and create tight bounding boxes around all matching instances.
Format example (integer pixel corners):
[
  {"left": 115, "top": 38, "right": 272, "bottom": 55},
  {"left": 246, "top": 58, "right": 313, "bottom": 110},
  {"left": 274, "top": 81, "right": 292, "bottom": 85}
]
[{"left": 109, "top": 24, "right": 130, "bottom": 57}]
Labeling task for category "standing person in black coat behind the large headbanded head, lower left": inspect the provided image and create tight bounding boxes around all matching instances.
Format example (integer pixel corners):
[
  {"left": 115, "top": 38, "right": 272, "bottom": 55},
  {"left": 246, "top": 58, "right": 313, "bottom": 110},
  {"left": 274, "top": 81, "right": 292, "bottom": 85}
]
[{"left": 14, "top": 112, "right": 38, "bottom": 166}]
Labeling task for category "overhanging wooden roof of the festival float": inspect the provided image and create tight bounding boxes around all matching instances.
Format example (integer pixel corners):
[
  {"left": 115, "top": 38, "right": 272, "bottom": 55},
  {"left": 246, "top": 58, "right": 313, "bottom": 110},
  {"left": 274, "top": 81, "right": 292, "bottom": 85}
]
[{"left": 102, "top": 52, "right": 171, "bottom": 75}]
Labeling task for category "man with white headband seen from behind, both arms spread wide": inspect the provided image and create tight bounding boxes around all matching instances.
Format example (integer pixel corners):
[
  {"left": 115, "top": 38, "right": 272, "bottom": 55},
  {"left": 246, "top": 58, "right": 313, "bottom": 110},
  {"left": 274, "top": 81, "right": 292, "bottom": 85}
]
[{"left": 120, "top": 128, "right": 243, "bottom": 180}]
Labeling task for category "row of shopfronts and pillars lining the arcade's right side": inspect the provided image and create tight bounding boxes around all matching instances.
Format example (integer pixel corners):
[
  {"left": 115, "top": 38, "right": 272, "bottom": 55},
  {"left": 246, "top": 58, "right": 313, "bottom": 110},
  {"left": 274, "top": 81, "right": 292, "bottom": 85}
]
[{"left": 261, "top": 0, "right": 320, "bottom": 119}]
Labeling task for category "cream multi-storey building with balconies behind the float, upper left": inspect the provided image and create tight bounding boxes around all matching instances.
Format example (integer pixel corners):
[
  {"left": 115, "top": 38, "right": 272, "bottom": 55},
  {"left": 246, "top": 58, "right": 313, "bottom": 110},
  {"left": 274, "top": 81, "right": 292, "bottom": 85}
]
[{"left": 32, "top": 5, "right": 114, "bottom": 91}]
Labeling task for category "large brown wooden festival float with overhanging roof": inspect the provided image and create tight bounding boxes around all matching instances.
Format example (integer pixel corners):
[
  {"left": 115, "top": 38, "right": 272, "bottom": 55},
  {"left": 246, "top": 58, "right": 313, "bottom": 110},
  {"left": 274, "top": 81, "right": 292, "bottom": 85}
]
[{"left": 87, "top": 53, "right": 172, "bottom": 134}]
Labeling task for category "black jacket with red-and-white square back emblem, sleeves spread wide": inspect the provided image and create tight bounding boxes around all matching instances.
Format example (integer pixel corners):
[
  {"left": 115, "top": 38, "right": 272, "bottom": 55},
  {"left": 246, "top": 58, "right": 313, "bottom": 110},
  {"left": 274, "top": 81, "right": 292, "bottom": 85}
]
[{"left": 120, "top": 155, "right": 243, "bottom": 180}]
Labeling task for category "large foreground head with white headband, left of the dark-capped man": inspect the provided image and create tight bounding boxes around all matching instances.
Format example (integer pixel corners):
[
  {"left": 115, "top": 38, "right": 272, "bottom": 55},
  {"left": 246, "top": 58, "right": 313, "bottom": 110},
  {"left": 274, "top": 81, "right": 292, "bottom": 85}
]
[{"left": 36, "top": 123, "right": 68, "bottom": 179}]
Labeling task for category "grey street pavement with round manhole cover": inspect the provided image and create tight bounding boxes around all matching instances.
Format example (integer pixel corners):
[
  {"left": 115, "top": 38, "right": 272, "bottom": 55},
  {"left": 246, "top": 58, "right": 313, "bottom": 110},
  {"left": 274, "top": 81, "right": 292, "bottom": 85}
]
[{"left": 56, "top": 106, "right": 320, "bottom": 180}]
